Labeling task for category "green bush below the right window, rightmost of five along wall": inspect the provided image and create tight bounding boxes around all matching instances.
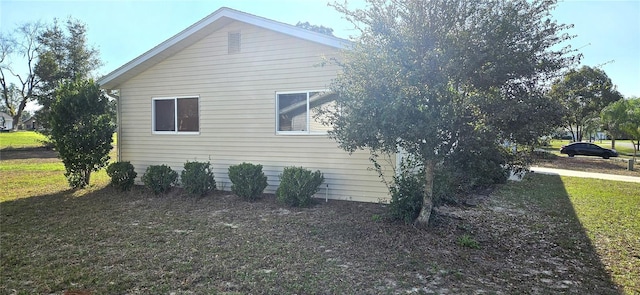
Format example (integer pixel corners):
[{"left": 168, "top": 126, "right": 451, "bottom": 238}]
[{"left": 276, "top": 167, "right": 324, "bottom": 207}]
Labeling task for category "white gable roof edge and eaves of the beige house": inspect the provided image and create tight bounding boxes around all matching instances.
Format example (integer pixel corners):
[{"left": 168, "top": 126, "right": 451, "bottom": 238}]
[{"left": 98, "top": 7, "right": 350, "bottom": 89}]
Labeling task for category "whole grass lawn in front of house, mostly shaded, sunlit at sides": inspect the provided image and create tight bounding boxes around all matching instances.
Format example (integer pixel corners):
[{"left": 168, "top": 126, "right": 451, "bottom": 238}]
[{"left": 0, "top": 151, "right": 640, "bottom": 294}]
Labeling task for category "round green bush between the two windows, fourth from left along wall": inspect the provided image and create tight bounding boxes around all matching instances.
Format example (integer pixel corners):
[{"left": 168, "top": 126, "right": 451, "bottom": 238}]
[{"left": 229, "top": 163, "right": 267, "bottom": 201}]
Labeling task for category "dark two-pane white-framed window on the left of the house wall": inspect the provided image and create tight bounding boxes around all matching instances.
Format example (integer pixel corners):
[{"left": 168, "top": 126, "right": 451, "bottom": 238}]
[{"left": 152, "top": 97, "right": 200, "bottom": 133}]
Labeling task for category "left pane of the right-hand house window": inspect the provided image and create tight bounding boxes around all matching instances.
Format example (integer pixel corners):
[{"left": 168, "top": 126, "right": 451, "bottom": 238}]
[{"left": 278, "top": 92, "right": 307, "bottom": 131}]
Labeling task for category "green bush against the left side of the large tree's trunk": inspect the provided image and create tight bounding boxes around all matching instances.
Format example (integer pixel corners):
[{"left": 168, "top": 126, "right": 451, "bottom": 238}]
[{"left": 389, "top": 161, "right": 424, "bottom": 224}]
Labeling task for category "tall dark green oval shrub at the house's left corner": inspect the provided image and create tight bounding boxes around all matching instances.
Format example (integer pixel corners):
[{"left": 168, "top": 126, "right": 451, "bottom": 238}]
[{"left": 49, "top": 79, "right": 115, "bottom": 188}]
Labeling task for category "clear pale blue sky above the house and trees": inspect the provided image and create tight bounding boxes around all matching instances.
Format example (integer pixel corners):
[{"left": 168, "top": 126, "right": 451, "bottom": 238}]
[{"left": 0, "top": 0, "right": 640, "bottom": 97}]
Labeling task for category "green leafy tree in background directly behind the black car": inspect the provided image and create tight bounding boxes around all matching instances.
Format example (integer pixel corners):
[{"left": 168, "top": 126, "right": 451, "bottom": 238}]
[{"left": 550, "top": 66, "right": 622, "bottom": 141}]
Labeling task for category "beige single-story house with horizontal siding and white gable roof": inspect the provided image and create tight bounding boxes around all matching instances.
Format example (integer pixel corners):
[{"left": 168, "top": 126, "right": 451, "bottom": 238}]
[{"left": 98, "top": 8, "right": 395, "bottom": 202}]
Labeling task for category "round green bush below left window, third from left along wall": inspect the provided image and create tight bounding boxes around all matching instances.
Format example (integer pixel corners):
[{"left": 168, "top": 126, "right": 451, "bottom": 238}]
[{"left": 180, "top": 161, "right": 216, "bottom": 196}]
